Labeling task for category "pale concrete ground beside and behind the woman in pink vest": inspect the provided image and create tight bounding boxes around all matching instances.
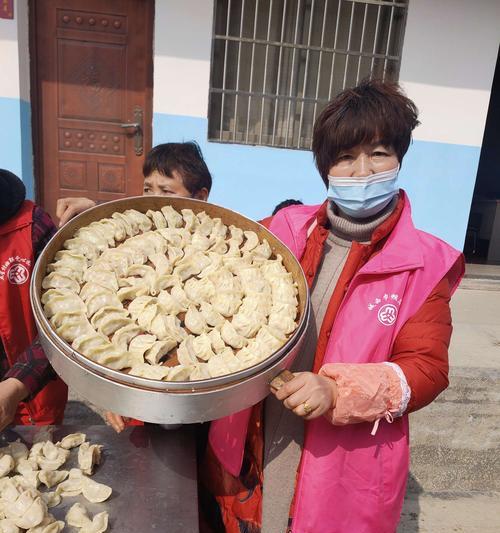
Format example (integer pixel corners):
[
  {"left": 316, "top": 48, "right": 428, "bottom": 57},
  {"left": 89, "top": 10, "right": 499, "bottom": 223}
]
[{"left": 66, "top": 279, "right": 500, "bottom": 533}]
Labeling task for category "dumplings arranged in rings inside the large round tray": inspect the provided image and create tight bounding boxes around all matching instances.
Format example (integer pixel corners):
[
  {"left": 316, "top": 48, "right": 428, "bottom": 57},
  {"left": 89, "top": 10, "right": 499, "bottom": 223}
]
[{"left": 42, "top": 206, "right": 298, "bottom": 381}]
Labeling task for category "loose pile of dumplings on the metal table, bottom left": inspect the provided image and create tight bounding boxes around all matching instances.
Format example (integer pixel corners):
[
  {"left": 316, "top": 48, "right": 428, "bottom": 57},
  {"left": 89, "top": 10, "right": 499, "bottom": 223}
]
[{"left": 0, "top": 433, "right": 112, "bottom": 533}]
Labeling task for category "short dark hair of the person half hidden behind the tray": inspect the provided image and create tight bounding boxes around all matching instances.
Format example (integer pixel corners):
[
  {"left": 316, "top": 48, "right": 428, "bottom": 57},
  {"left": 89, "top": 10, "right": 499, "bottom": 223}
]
[{"left": 142, "top": 141, "right": 212, "bottom": 194}]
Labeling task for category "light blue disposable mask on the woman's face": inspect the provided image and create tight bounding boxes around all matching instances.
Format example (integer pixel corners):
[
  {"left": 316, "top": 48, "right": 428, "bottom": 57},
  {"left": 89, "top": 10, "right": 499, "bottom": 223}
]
[{"left": 327, "top": 165, "right": 399, "bottom": 218}]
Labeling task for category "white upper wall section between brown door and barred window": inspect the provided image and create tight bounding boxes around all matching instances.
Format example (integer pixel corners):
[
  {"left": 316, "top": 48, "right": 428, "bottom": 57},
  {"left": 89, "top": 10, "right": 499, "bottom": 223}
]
[{"left": 153, "top": 0, "right": 213, "bottom": 118}]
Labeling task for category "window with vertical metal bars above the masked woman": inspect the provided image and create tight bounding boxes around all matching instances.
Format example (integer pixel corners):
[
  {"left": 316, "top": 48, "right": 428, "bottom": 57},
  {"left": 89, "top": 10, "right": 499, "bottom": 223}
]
[{"left": 208, "top": 0, "right": 408, "bottom": 149}]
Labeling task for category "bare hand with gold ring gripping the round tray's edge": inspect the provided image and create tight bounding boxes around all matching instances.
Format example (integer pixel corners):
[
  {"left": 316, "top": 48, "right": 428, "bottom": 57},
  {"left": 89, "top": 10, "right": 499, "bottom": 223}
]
[{"left": 271, "top": 372, "right": 337, "bottom": 420}]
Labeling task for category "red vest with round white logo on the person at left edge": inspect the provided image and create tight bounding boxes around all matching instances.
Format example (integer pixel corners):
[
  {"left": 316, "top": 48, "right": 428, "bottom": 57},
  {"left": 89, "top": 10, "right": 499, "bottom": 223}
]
[{"left": 0, "top": 200, "right": 68, "bottom": 425}]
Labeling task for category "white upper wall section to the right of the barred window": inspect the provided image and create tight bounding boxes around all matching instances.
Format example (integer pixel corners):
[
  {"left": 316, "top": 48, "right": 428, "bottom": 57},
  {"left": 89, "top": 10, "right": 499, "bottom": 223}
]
[{"left": 400, "top": 0, "right": 500, "bottom": 146}]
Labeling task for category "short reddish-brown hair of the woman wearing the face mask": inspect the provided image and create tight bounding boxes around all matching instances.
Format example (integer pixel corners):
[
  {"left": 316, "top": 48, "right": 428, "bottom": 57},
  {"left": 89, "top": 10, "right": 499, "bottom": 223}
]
[{"left": 312, "top": 80, "right": 419, "bottom": 183}]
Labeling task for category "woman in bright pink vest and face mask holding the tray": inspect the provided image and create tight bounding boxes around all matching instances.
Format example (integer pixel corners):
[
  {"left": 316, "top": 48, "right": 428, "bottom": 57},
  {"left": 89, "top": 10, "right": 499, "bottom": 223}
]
[{"left": 200, "top": 81, "right": 464, "bottom": 533}]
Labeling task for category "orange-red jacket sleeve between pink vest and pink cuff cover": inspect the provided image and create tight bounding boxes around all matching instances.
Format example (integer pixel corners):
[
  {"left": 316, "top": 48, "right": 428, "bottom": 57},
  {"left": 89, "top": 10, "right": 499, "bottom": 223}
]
[{"left": 391, "top": 278, "right": 452, "bottom": 412}]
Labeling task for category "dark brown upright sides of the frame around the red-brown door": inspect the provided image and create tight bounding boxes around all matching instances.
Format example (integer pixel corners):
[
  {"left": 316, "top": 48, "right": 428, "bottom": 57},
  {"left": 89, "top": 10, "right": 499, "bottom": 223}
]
[{"left": 28, "top": 0, "right": 156, "bottom": 205}]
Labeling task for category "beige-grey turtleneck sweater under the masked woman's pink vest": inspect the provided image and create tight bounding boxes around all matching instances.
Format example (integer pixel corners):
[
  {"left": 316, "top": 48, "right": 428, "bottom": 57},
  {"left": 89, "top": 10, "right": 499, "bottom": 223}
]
[{"left": 262, "top": 196, "right": 398, "bottom": 533}]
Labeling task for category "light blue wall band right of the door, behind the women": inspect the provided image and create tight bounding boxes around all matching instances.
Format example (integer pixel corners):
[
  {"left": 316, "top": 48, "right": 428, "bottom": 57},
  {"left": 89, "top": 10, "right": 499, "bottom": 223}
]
[{"left": 153, "top": 113, "right": 480, "bottom": 249}]
